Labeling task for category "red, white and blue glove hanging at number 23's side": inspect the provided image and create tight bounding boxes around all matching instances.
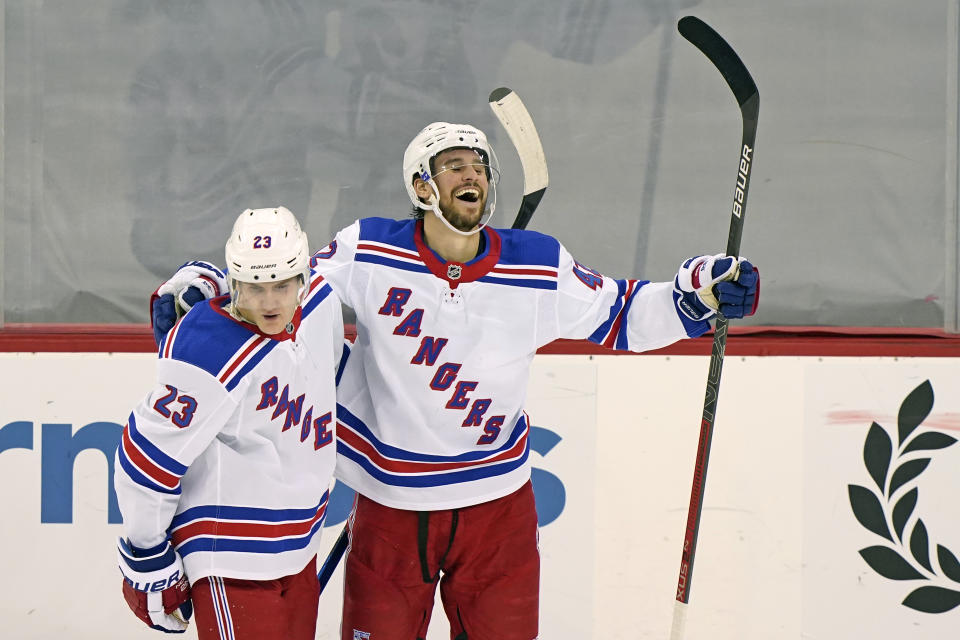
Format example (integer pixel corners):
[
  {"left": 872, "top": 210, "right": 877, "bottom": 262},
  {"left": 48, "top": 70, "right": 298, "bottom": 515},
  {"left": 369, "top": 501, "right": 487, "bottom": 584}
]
[{"left": 117, "top": 538, "right": 193, "bottom": 633}]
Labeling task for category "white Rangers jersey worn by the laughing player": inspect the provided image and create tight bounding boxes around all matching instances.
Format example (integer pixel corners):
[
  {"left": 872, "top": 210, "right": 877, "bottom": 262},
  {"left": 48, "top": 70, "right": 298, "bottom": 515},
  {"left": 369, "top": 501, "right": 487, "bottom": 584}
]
[{"left": 311, "top": 214, "right": 709, "bottom": 510}]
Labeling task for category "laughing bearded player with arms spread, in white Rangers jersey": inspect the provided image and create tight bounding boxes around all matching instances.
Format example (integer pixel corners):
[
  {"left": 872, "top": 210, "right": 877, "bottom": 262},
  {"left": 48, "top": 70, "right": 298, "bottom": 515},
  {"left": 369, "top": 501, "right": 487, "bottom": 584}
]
[{"left": 153, "top": 122, "right": 758, "bottom": 640}]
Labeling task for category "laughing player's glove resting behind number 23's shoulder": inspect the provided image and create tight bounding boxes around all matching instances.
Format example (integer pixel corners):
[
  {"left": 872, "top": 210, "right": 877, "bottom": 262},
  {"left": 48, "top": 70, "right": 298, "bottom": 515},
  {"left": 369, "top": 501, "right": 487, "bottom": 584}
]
[{"left": 150, "top": 260, "right": 229, "bottom": 344}]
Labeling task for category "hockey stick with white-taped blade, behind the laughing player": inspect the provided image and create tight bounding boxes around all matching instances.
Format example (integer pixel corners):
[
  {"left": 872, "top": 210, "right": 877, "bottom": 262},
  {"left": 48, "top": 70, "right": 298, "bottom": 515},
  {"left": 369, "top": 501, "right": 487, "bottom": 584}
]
[{"left": 317, "top": 87, "right": 548, "bottom": 593}]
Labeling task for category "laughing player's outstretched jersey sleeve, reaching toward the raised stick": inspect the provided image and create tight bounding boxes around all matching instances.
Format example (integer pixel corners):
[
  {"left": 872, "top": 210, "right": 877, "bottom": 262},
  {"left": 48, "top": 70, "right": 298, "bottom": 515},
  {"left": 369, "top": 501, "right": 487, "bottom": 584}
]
[{"left": 557, "top": 245, "right": 710, "bottom": 351}]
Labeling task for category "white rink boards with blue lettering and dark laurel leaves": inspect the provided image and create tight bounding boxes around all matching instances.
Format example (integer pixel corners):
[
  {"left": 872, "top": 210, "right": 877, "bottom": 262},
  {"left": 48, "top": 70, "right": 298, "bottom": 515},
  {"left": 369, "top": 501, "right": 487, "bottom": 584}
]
[{"left": 0, "top": 353, "right": 960, "bottom": 640}]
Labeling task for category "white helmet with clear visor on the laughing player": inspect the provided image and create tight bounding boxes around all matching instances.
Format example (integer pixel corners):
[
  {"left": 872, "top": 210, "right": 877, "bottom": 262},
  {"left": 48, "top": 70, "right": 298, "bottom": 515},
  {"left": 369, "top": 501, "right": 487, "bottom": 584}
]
[{"left": 403, "top": 122, "right": 500, "bottom": 235}]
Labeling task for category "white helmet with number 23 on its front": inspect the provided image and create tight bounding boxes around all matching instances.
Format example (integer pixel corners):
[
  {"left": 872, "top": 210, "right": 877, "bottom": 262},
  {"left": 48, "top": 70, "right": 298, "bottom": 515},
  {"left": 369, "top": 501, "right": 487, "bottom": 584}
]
[{"left": 226, "top": 207, "right": 310, "bottom": 291}]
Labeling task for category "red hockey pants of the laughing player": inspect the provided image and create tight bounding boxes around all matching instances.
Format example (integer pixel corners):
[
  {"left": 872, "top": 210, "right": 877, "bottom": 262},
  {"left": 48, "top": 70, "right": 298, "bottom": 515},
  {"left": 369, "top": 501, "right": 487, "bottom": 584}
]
[{"left": 341, "top": 482, "right": 540, "bottom": 640}]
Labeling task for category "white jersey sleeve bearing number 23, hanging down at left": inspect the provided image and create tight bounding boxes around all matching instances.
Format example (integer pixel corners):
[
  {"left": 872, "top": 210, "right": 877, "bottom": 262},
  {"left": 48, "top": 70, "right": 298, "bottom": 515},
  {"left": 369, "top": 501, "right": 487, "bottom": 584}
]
[{"left": 114, "top": 359, "right": 236, "bottom": 548}]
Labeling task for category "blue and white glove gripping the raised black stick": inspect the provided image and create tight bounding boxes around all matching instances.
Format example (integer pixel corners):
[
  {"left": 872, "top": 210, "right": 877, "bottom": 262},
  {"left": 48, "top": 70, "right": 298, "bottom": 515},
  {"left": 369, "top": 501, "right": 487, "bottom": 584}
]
[{"left": 673, "top": 253, "right": 760, "bottom": 320}]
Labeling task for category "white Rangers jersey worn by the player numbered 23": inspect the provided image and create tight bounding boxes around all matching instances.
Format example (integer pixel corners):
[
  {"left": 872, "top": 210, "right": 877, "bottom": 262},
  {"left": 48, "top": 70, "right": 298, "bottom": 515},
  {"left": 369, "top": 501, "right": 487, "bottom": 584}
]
[{"left": 114, "top": 274, "right": 343, "bottom": 583}]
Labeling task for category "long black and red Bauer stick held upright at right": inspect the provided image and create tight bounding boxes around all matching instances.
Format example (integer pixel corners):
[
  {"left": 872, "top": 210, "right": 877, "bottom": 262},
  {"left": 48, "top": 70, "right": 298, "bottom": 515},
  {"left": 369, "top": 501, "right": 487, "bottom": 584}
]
[{"left": 670, "top": 16, "right": 760, "bottom": 640}]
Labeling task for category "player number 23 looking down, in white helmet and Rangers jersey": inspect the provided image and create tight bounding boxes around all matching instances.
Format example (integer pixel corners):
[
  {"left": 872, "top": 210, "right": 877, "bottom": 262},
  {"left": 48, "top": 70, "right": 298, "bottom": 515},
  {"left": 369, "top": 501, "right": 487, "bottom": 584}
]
[{"left": 114, "top": 207, "right": 343, "bottom": 640}]
